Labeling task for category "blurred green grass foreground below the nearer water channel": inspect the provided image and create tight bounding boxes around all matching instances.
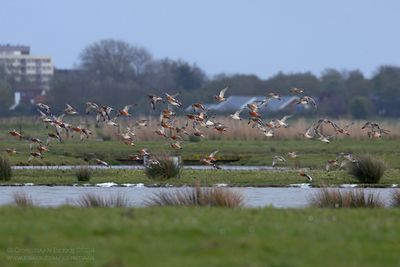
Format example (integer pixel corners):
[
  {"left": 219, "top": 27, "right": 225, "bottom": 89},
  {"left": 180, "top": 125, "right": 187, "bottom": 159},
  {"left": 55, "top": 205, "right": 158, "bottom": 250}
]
[{"left": 0, "top": 207, "right": 400, "bottom": 267}]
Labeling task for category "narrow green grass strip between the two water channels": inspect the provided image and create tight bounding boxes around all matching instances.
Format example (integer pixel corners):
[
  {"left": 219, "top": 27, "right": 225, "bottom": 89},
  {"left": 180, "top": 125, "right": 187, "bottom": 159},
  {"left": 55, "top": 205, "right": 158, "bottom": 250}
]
[{"left": 4, "top": 169, "right": 400, "bottom": 186}]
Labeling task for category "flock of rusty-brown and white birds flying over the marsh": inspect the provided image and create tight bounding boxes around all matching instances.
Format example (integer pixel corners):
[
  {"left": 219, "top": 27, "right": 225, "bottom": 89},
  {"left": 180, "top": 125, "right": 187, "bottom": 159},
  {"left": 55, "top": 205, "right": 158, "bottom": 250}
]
[{"left": 6, "top": 86, "right": 390, "bottom": 181}]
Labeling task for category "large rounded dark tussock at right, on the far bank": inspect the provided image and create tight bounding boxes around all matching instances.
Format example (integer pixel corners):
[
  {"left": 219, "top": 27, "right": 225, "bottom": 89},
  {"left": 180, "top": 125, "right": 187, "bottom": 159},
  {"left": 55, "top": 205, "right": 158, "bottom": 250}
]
[{"left": 348, "top": 154, "right": 386, "bottom": 183}]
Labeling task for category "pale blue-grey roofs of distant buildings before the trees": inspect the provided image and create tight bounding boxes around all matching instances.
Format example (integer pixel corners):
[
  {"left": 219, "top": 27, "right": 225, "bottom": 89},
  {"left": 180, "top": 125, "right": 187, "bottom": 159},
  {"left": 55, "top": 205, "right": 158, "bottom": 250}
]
[{"left": 186, "top": 96, "right": 299, "bottom": 112}]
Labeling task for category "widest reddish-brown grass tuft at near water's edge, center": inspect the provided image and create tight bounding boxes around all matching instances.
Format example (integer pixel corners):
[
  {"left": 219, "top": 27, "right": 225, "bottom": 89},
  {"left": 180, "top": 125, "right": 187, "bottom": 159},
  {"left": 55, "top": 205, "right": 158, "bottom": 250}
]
[{"left": 146, "top": 185, "right": 244, "bottom": 208}]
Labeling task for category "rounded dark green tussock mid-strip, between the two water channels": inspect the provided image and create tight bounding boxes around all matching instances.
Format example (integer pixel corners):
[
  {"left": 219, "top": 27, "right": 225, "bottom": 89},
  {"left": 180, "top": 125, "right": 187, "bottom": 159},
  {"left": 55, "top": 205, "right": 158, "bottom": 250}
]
[{"left": 145, "top": 155, "right": 182, "bottom": 180}]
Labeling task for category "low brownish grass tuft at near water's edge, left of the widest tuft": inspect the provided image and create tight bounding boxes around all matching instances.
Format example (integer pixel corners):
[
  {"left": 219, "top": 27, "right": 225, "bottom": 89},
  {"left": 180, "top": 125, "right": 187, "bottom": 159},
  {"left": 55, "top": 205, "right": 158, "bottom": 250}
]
[{"left": 76, "top": 193, "right": 128, "bottom": 208}]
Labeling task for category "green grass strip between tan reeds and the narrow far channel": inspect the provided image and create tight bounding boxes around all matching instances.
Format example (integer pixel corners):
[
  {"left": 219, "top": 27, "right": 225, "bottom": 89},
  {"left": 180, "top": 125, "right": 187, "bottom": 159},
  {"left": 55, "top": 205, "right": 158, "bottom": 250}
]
[{"left": 0, "top": 138, "right": 400, "bottom": 168}]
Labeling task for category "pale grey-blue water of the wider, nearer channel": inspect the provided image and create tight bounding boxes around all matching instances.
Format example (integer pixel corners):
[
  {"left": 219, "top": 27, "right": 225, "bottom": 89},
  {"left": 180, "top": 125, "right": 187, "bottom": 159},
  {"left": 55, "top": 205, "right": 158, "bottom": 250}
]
[{"left": 0, "top": 184, "right": 392, "bottom": 208}]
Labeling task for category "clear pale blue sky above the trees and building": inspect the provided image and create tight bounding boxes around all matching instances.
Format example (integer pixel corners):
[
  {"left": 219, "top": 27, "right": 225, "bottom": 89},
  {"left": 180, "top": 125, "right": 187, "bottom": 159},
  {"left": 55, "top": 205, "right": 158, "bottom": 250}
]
[{"left": 0, "top": 0, "right": 400, "bottom": 79}]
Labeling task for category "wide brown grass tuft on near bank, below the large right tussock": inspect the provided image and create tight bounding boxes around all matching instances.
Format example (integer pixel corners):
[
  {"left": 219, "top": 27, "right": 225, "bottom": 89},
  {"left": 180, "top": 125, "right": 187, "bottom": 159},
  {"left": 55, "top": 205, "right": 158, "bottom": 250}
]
[{"left": 310, "top": 188, "right": 384, "bottom": 208}]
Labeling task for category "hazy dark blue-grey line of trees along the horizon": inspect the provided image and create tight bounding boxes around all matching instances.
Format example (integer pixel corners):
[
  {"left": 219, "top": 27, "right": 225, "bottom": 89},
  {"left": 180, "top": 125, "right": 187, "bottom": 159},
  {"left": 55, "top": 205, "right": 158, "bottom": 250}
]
[{"left": 0, "top": 39, "right": 400, "bottom": 118}]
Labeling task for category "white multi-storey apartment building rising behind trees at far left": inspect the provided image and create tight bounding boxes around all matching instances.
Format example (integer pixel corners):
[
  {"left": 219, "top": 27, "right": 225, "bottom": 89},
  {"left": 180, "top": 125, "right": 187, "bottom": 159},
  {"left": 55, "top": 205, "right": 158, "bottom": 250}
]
[{"left": 0, "top": 45, "right": 54, "bottom": 90}]
